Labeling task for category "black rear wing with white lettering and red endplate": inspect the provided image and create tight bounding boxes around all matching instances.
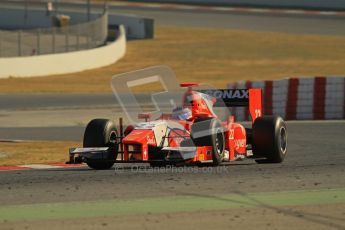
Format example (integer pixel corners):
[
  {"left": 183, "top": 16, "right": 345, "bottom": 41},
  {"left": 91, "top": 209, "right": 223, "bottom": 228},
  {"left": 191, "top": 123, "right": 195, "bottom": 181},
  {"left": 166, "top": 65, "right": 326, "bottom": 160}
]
[{"left": 197, "top": 89, "right": 262, "bottom": 122}]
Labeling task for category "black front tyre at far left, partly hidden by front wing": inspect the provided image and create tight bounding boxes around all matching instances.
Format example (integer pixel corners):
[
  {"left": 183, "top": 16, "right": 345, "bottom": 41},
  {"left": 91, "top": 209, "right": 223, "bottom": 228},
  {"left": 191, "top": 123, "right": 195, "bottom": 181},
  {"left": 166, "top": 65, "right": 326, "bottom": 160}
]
[{"left": 83, "top": 119, "right": 118, "bottom": 170}]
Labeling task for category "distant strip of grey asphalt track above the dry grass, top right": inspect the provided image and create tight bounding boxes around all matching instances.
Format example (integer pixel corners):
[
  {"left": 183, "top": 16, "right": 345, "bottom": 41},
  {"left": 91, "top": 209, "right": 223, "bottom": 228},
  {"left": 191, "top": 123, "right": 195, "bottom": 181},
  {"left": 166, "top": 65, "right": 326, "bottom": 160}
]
[{"left": 110, "top": 6, "right": 345, "bottom": 35}]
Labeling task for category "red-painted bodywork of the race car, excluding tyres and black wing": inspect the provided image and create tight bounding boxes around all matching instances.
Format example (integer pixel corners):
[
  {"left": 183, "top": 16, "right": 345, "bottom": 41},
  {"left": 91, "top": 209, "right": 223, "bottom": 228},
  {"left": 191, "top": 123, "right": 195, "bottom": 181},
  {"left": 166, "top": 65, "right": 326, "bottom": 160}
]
[{"left": 118, "top": 83, "right": 262, "bottom": 163}]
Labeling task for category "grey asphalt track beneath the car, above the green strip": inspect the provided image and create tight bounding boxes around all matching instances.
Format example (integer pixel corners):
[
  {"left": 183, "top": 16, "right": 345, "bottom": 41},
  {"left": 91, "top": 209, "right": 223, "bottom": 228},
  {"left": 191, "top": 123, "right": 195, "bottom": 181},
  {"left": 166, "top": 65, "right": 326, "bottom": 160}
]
[{"left": 0, "top": 121, "right": 345, "bottom": 202}]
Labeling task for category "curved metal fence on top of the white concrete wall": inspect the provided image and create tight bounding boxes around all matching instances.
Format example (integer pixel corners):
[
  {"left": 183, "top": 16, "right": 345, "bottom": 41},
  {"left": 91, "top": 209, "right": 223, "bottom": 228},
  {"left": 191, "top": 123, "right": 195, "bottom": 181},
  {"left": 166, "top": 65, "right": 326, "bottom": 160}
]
[{"left": 0, "top": 10, "right": 108, "bottom": 57}]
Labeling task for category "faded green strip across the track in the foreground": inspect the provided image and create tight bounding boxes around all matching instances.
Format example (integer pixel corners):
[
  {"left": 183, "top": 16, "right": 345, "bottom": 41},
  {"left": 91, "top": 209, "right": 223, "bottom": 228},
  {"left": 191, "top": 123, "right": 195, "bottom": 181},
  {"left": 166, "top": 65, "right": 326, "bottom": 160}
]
[{"left": 0, "top": 189, "right": 345, "bottom": 221}]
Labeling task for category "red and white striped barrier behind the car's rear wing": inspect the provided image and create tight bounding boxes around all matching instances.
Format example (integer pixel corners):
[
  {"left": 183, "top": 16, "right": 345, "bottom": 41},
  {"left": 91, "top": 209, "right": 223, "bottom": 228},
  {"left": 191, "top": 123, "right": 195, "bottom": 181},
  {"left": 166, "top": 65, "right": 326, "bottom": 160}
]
[{"left": 229, "top": 77, "right": 345, "bottom": 121}]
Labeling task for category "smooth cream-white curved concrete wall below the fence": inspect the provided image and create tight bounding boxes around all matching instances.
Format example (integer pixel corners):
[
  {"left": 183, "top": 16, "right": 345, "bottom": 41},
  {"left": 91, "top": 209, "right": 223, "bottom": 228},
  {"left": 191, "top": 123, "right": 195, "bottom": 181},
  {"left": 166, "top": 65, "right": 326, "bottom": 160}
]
[{"left": 0, "top": 26, "right": 126, "bottom": 78}]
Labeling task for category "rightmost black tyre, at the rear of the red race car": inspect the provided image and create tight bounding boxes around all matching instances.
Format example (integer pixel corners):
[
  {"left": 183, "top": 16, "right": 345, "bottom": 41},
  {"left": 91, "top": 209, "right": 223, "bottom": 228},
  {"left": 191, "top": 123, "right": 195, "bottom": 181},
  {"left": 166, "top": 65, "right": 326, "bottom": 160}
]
[{"left": 252, "top": 116, "right": 287, "bottom": 163}]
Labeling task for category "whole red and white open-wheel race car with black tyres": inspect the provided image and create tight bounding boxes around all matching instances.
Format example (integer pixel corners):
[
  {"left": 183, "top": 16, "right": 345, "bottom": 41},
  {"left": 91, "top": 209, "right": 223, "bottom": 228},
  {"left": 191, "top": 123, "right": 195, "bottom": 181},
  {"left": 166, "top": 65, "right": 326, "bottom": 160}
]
[{"left": 68, "top": 83, "right": 287, "bottom": 169}]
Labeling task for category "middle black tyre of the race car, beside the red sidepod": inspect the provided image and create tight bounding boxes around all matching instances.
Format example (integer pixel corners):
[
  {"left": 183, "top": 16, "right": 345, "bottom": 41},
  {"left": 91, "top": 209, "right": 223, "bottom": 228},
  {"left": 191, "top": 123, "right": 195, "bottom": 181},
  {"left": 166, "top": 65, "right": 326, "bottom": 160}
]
[{"left": 191, "top": 118, "right": 225, "bottom": 166}]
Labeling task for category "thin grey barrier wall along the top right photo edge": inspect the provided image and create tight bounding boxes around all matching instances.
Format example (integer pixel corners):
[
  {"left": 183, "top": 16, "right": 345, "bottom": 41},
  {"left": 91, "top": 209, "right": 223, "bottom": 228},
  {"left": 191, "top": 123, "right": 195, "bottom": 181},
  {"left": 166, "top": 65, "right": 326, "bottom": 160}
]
[{"left": 125, "top": 0, "right": 345, "bottom": 10}]
